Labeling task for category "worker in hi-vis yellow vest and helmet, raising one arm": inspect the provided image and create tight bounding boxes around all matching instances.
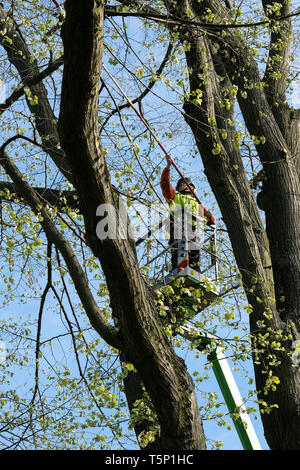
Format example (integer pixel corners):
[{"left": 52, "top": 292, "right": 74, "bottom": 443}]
[{"left": 160, "top": 155, "right": 216, "bottom": 271}]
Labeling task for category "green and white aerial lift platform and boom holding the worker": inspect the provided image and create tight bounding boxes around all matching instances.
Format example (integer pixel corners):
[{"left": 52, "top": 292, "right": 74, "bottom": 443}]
[{"left": 139, "top": 215, "right": 261, "bottom": 450}]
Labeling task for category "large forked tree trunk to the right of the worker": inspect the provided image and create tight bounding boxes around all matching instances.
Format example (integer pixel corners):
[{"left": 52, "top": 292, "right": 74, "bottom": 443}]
[{"left": 165, "top": 0, "right": 300, "bottom": 449}]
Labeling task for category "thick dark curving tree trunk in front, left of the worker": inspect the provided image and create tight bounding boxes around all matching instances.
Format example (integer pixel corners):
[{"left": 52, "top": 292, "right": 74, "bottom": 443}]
[{"left": 59, "top": 0, "right": 205, "bottom": 450}]
